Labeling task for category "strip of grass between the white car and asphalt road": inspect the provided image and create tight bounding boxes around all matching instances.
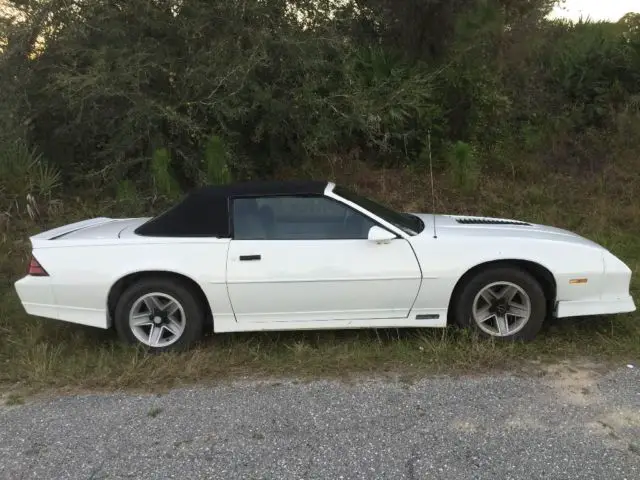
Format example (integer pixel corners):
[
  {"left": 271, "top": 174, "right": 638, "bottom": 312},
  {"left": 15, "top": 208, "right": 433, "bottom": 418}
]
[{"left": 0, "top": 284, "right": 640, "bottom": 391}]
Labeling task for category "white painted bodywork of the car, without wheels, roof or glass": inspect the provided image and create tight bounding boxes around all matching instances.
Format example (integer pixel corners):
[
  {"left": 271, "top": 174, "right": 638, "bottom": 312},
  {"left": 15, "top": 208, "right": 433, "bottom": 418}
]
[{"left": 15, "top": 183, "right": 636, "bottom": 332}]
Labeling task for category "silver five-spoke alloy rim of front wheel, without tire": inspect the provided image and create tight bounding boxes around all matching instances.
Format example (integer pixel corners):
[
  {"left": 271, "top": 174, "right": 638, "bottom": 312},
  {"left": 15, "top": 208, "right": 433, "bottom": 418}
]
[{"left": 472, "top": 282, "right": 531, "bottom": 337}]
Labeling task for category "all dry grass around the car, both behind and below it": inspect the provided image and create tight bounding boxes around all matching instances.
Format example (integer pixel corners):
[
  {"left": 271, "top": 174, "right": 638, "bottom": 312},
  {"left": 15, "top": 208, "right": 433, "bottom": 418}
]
[{"left": 0, "top": 157, "right": 640, "bottom": 391}]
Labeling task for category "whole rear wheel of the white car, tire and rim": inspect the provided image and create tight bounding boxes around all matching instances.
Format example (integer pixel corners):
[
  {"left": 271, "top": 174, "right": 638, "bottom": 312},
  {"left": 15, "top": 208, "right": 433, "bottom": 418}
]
[{"left": 114, "top": 277, "right": 205, "bottom": 352}]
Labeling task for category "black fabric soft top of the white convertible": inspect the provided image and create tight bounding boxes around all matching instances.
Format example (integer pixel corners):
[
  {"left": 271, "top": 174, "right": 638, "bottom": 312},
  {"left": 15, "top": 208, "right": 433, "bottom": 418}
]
[{"left": 135, "top": 180, "right": 327, "bottom": 238}]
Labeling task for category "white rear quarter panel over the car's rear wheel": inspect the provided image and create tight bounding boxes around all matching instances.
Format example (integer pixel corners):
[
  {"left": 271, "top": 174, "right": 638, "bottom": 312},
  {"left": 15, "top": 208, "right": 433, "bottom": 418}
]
[{"left": 33, "top": 238, "right": 233, "bottom": 328}]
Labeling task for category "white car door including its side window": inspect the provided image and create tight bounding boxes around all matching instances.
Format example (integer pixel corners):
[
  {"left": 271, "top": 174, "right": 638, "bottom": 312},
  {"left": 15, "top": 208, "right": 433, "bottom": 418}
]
[{"left": 222, "top": 196, "right": 421, "bottom": 323}]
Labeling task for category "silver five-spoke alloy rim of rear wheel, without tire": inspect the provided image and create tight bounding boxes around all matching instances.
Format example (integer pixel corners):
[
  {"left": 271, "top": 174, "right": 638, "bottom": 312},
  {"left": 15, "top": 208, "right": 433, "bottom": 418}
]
[{"left": 129, "top": 292, "right": 187, "bottom": 348}]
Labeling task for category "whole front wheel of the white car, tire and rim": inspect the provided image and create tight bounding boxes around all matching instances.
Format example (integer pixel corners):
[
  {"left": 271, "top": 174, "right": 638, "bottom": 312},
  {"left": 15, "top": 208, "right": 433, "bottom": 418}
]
[{"left": 454, "top": 267, "right": 547, "bottom": 341}]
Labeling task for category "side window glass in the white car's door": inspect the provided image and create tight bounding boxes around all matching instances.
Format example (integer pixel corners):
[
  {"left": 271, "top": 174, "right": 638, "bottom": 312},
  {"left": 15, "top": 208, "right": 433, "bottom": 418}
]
[{"left": 233, "top": 196, "right": 375, "bottom": 240}]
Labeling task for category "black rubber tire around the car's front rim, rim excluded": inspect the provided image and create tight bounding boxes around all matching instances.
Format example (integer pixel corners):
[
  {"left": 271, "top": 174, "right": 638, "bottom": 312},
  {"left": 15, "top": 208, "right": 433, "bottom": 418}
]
[{"left": 453, "top": 267, "right": 547, "bottom": 341}]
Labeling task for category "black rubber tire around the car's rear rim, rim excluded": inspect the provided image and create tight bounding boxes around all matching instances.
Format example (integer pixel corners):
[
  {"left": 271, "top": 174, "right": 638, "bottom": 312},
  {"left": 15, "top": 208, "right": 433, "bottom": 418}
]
[{"left": 114, "top": 277, "right": 206, "bottom": 352}]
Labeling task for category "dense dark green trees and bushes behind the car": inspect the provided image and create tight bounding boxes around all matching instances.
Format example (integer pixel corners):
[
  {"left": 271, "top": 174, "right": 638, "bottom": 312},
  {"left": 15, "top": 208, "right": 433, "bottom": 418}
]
[{"left": 0, "top": 0, "right": 640, "bottom": 196}]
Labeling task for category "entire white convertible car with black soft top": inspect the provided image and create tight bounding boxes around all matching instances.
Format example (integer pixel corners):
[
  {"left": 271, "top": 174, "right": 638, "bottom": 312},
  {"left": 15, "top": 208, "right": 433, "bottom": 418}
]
[{"left": 15, "top": 182, "right": 636, "bottom": 351}]
